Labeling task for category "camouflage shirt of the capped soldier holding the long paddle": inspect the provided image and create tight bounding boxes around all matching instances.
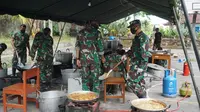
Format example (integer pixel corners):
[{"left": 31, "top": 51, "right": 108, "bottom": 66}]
[{"left": 129, "top": 32, "right": 151, "bottom": 61}]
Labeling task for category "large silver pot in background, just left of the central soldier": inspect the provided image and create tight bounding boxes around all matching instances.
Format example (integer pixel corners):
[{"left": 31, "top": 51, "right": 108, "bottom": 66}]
[{"left": 55, "top": 49, "right": 72, "bottom": 65}]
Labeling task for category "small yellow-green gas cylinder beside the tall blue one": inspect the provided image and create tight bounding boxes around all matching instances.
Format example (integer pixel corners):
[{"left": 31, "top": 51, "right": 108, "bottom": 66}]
[{"left": 179, "top": 82, "right": 192, "bottom": 97}]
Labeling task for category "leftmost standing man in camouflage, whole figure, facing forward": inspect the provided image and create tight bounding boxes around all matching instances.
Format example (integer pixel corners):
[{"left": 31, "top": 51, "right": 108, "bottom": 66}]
[{"left": 11, "top": 24, "right": 30, "bottom": 76}]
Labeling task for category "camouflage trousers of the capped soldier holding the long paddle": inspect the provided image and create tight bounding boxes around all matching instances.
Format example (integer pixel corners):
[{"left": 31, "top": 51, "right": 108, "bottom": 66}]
[{"left": 125, "top": 60, "right": 148, "bottom": 98}]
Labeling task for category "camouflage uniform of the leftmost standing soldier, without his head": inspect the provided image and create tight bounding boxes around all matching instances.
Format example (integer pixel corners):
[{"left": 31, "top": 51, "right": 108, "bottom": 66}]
[{"left": 12, "top": 31, "right": 29, "bottom": 71}]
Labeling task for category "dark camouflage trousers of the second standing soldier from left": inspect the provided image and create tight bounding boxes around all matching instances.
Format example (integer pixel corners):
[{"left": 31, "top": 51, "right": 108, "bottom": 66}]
[{"left": 37, "top": 61, "right": 53, "bottom": 83}]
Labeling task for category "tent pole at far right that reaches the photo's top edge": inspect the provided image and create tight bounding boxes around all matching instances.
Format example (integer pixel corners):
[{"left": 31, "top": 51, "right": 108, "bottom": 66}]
[{"left": 180, "top": 0, "right": 200, "bottom": 70}]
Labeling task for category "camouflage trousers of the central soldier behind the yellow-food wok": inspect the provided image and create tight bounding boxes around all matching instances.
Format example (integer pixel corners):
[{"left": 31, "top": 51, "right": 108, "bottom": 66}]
[{"left": 81, "top": 63, "right": 101, "bottom": 93}]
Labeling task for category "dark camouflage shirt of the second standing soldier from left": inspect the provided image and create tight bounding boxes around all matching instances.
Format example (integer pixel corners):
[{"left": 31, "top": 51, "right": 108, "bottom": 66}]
[{"left": 31, "top": 32, "right": 53, "bottom": 61}]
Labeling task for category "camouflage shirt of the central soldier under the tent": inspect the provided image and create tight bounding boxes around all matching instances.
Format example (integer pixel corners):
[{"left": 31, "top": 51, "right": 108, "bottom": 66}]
[{"left": 75, "top": 28, "right": 104, "bottom": 56}]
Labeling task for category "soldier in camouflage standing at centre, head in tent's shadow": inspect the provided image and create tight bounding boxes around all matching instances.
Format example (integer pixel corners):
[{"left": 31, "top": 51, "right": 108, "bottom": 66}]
[{"left": 75, "top": 21, "right": 105, "bottom": 93}]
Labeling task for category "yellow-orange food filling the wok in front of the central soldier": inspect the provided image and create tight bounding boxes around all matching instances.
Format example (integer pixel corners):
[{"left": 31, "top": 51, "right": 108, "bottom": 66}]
[{"left": 68, "top": 92, "right": 97, "bottom": 101}]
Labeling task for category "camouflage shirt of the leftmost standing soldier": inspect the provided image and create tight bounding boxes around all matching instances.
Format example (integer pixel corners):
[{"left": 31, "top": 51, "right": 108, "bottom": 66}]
[{"left": 12, "top": 31, "right": 29, "bottom": 53}]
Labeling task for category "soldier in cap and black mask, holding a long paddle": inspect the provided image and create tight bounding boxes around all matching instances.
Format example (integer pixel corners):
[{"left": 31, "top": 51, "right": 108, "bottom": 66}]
[{"left": 126, "top": 20, "right": 151, "bottom": 98}]
